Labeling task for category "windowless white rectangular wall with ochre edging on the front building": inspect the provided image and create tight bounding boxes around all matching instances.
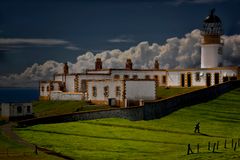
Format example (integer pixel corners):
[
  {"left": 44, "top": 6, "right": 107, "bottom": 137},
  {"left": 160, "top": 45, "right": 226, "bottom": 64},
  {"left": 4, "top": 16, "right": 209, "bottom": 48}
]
[{"left": 125, "top": 80, "right": 156, "bottom": 100}]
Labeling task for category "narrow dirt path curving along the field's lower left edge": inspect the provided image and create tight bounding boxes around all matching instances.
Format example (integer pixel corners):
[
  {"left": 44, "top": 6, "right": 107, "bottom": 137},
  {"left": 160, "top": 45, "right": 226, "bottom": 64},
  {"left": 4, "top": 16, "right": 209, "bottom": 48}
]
[{"left": 0, "top": 122, "right": 73, "bottom": 160}]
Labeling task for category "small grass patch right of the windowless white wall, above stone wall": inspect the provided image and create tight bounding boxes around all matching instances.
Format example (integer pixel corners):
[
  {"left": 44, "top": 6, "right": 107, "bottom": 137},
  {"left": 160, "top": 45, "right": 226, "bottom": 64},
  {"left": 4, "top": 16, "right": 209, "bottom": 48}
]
[{"left": 157, "top": 87, "right": 203, "bottom": 99}]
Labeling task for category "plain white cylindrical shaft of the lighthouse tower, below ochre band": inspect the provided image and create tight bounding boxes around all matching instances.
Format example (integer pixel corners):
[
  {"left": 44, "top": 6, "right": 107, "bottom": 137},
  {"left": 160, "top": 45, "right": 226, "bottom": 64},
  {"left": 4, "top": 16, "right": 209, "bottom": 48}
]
[{"left": 201, "top": 44, "right": 222, "bottom": 68}]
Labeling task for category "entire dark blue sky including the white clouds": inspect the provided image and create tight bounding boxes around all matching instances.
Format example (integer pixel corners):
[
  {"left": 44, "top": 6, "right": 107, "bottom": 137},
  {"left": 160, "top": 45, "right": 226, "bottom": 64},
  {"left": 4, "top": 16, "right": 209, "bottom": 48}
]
[{"left": 0, "top": 0, "right": 240, "bottom": 87}]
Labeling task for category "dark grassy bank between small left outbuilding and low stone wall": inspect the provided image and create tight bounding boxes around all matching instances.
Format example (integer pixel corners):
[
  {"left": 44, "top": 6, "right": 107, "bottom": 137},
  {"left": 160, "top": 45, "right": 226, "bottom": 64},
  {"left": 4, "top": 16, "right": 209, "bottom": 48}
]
[{"left": 33, "top": 101, "right": 109, "bottom": 117}]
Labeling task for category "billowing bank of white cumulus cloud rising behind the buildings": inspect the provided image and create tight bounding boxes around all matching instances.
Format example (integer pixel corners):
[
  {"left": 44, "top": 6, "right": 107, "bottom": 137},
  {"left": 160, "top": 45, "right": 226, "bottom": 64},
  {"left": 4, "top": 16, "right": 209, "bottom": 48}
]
[{"left": 0, "top": 29, "right": 240, "bottom": 87}]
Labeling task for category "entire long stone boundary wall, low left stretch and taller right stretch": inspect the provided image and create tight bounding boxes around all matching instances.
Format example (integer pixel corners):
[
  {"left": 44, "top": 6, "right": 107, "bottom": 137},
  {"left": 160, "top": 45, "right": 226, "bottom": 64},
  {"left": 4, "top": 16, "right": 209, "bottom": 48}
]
[{"left": 18, "top": 80, "right": 240, "bottom": 127}]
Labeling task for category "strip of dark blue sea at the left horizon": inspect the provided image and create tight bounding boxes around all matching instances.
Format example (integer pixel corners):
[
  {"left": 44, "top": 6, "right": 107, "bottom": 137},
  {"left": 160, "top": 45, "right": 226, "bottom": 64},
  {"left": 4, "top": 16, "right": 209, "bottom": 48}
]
[{"left": 0, "top": 88, "right": 39, "bottom": 103}]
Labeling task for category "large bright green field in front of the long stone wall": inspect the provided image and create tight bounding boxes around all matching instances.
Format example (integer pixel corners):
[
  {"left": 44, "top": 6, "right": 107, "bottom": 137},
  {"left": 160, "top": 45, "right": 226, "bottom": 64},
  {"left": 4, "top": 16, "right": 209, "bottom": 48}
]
[{"left": 17, "top": 89, "right": 240, "bottom": 160}]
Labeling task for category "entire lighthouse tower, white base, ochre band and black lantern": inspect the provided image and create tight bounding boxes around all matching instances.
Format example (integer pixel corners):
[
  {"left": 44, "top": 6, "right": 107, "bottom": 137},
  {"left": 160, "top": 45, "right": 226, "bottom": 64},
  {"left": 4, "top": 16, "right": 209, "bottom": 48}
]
[{"left": 201, "top": 9, "right": 223, "bottom": 68}]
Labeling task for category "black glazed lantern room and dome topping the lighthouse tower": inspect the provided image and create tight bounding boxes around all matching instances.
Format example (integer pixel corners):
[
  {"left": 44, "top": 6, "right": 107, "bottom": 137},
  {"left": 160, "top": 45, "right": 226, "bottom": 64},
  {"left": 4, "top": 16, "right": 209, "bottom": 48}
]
[{"left": 201, "top": 9, "right": 223, "bottom": 36}]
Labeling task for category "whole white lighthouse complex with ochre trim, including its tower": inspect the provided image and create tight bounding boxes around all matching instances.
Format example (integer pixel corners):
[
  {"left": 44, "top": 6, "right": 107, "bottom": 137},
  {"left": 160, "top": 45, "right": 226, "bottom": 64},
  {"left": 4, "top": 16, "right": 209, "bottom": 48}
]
[{"left": 39, "top": 9, "right": 240, "bottom": 107}]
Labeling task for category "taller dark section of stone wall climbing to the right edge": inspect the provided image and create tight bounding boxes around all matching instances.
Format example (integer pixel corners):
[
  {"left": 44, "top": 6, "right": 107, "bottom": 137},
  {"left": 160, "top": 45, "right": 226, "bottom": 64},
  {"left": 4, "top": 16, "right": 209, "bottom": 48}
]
[{"left": 143, "top": 80, "right": 240, "bottom": 120}]
